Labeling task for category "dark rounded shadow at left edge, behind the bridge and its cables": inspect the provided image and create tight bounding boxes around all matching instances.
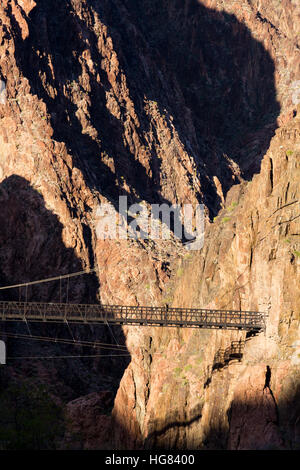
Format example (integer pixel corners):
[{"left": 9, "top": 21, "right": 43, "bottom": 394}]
[{"left": 0, "top": 175, "right": 129, "bottom": 407}]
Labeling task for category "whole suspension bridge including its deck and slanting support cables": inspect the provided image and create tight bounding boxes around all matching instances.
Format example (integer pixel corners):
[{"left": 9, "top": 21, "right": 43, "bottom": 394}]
[{"left": 0, "top": 268, "right": 267, "bottom": 364}]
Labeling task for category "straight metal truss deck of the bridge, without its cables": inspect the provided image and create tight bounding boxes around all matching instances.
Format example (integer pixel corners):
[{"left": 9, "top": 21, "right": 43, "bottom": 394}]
[{"left": 0, "top": 302, "right": 266, "bottom": 331}]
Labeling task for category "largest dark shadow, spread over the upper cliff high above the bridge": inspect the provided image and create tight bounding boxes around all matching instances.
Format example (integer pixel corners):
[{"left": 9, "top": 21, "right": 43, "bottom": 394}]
[{"left": 11, "top": 0, "right": 280, "bottom": 222}]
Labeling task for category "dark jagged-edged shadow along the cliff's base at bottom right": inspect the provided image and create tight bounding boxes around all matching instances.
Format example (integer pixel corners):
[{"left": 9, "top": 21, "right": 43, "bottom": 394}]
[{"left": 111, "top": 373, "right": 300, "bottom": 450}]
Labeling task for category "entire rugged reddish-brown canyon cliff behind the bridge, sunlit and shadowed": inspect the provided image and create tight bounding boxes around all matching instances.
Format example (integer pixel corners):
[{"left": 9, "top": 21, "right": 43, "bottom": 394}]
[{"left": 0, "top": 0, "right": 300, "bottom": 449}]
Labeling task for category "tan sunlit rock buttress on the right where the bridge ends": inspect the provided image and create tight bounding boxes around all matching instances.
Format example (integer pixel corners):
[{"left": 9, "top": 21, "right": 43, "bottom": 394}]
[{"left": 114, "top": 108, "right": 300, "bottom": 449}]
